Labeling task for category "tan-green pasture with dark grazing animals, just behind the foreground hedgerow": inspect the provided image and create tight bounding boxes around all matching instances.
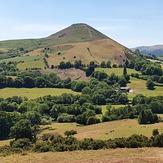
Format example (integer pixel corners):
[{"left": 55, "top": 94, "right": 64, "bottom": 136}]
[{"left": 42, "top": 119, "right": 163, "bottom": 140}]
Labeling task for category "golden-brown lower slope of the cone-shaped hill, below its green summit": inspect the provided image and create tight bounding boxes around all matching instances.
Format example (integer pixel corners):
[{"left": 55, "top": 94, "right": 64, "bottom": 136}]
[{"left": 26, "top": 39, "right": 134, "bottom": 66}]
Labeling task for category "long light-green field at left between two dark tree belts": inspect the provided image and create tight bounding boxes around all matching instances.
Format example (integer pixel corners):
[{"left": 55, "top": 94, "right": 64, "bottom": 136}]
[{"left": 0, "top": 88, "right": 79, "bottom": 99}]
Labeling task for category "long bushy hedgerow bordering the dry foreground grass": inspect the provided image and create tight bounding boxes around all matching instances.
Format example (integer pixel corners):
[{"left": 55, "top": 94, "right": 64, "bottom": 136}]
[{"left": 0, "top": 129, "right": 163, "bottom": 156}]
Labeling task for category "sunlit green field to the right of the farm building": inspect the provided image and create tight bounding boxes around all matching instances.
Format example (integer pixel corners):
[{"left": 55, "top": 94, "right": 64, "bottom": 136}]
[{"left": 127, "top": 77, "right": 163, "bottom": 99}]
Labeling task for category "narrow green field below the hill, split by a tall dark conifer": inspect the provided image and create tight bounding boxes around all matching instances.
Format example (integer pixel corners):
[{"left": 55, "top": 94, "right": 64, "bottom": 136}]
[{"left": 96, "top": 68, "right": 140, "bottom": 76}]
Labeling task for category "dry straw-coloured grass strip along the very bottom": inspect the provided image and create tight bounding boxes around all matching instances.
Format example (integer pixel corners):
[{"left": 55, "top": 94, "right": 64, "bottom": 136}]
[{"left": 0, "top": 148, "right": 163, "bottom": 163}]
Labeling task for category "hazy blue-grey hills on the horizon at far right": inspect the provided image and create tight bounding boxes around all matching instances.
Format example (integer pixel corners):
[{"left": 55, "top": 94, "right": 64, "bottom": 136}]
[{"left": 132, "top": 45, "right": 163, "bottom": 56}]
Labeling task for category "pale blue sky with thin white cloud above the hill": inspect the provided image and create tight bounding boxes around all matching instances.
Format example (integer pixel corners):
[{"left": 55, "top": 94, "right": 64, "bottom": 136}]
[{"left": 0, "top": 0, "right": 163, "bottom": 48}]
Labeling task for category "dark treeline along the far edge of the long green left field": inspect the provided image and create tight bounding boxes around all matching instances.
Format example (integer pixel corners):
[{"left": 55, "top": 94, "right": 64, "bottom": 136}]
[{"left": 0, "top": 71, "right": 130, "bottom": 92}]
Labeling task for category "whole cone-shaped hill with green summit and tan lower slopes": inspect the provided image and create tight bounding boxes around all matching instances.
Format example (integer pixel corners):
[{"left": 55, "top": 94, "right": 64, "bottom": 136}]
[{"left": 0, "top": 23, "right": 136, "bottom": 66}]
